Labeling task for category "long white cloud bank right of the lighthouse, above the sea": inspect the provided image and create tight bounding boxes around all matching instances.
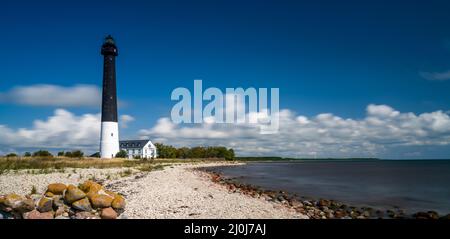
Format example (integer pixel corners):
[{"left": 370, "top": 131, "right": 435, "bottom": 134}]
[{"left": 140, "top": 104, "right": 450, "bottom": 157}]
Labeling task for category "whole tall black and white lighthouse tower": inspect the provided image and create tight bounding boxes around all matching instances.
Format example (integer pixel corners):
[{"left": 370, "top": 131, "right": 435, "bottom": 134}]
[{"left": 100, "top": 35, "right": 119, "bottom": 158}]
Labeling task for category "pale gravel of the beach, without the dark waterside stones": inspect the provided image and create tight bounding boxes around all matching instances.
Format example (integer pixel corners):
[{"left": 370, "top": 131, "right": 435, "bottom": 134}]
[{"left": 0, "top": 163, "right": 305, "bottom": 219}]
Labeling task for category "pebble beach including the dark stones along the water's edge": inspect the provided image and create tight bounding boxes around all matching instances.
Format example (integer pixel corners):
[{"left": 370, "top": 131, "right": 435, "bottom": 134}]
[{"left": 0, "top": 161, "right": 450, "bottom": 219}]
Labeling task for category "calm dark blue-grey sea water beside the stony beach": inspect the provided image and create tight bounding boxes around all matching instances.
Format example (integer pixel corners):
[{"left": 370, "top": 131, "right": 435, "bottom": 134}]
[{"left": 209, "top": 160, "right": 450, "bottom": 214}]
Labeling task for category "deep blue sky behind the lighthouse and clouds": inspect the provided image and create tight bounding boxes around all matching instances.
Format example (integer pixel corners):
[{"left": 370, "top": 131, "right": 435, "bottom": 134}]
[{"left": 0, "top": 1, "right": 450, "bottom": 158}]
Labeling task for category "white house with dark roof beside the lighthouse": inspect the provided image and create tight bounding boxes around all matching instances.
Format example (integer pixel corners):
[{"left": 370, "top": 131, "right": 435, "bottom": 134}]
[{"left": 119, "top": 140, "right": 158, "bottom": 159}]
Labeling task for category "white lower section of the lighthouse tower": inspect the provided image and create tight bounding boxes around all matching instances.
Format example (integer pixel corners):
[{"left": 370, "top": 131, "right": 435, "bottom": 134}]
[{"left": 100, "top": 122, "right": 119, "bottom": 159}]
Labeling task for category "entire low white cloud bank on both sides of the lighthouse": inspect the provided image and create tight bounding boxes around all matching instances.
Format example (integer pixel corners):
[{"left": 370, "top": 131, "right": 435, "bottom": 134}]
[{"left": 0, "top": 104, "right": 450, "bottom": 157}]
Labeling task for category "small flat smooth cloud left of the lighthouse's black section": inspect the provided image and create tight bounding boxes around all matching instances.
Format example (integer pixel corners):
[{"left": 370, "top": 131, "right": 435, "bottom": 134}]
[{"left": 0, "top": 84, "right": 101, "bottom": 107}]
